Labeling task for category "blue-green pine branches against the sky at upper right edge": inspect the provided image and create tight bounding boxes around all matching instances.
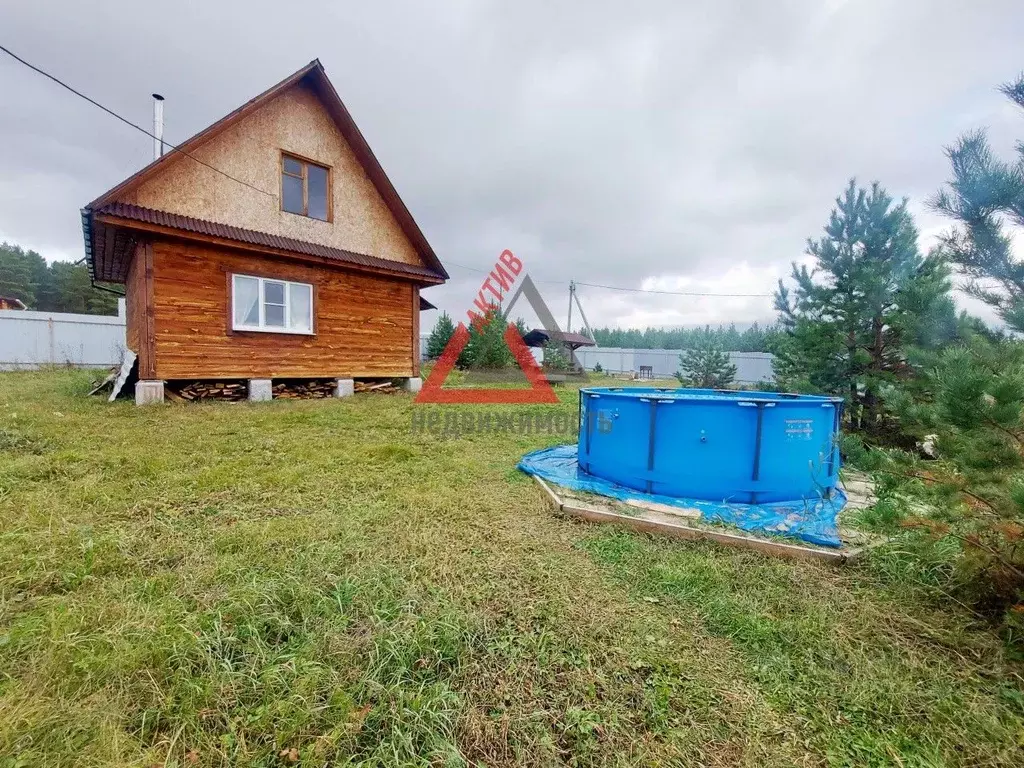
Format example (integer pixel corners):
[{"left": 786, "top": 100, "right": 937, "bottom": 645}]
[{"left": 931, "top": 75, "right": 1024, "bottom": 333}]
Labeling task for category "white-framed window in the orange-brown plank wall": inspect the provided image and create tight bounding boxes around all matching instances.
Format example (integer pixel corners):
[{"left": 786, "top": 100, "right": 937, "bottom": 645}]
[{"left": 231, "top": 274, "right": 313, "bottom": 334}]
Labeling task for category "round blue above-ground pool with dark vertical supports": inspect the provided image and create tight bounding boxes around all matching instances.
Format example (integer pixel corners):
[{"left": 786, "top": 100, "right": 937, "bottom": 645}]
[{"left": 578, "top": 387, "right": 843, "bottom": 504}]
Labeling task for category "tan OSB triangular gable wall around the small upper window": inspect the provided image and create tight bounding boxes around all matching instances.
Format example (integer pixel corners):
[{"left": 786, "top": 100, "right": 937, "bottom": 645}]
[{"left": 120, "top": 84, "right": 423, "bottom": 264}]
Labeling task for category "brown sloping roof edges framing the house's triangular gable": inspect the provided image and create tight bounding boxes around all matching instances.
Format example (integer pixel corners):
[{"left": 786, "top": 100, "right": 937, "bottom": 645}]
[{"left": 89, "top": 58, "right": 449, "bottom": 280}]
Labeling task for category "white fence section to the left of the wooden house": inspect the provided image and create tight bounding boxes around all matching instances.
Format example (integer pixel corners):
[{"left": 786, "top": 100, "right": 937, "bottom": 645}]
[{"left": 0, "top": 299, "right": 125, "bottom": 371}]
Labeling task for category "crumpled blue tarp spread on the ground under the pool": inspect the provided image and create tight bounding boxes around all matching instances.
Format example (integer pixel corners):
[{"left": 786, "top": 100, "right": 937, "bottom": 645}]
[{"left": 519, "top": 445, "right": 846, "bottom": 547}]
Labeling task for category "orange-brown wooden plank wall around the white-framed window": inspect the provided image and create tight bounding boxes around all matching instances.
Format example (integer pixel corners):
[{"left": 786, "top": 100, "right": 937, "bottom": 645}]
[{"left": 145, "top": 241, "right": 419, "bottom": 379}]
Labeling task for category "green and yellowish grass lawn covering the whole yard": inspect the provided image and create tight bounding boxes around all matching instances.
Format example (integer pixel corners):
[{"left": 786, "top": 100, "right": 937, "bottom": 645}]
[{"left": 0, "top": 372, "right": 1024, "bottom": 768}]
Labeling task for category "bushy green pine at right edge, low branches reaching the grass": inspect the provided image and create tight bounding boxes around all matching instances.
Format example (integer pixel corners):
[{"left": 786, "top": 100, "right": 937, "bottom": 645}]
[{"left": 890, "top": 334, "right": 1024, "bottom": 626}]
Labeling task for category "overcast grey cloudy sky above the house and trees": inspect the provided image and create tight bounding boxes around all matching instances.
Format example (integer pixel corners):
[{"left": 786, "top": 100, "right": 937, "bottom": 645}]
[{"left": 0, "top": 0, "right": 1024, "bottom": 326}]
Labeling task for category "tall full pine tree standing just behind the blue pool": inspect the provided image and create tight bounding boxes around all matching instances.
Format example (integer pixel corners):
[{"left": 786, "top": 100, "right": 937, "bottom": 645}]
[{"left": 775, "top": 179, "right": 949, "bottom": 430}]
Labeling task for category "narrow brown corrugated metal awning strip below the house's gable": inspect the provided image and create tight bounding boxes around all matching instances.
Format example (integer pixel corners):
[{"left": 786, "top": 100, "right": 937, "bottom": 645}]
[{"left": 92, "top": 203, "right": 442, "bottom": 281}]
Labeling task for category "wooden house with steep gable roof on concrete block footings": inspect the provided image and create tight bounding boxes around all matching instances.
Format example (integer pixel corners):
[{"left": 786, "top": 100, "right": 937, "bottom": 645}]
[{"left": 82, "top": 60, "right": 447, "bottom": 401}]
